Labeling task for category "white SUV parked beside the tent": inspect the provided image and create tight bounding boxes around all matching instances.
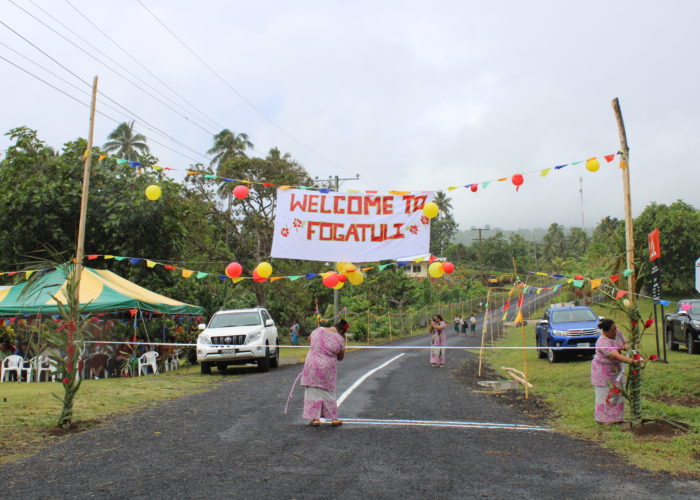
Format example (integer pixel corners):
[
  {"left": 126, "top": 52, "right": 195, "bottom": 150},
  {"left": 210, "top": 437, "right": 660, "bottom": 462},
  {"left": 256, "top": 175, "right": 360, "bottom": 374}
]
[{"left": 197, "top": 307, "right": 280, "bottom": 374}]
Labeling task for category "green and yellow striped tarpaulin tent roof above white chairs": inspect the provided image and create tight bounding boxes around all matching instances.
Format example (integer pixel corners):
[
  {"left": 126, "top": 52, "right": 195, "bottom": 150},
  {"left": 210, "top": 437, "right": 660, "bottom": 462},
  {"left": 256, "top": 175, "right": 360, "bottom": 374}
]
[{"left": 0, "top": 267, "right": 204, "bottom": 316}]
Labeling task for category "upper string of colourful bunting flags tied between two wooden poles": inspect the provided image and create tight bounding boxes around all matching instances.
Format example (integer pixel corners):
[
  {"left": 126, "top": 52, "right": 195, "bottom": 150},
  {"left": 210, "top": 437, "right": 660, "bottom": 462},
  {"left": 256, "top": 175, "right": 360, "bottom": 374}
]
[{"left": 85, "top": 151, "right": 627, "bottom": 195}]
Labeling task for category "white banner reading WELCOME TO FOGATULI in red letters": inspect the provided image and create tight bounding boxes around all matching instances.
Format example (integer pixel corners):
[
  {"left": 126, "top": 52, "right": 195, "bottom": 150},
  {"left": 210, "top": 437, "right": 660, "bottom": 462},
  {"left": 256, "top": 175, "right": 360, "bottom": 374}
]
[{"left": 272, "top": 189, "right": 433, "bottom": 262}]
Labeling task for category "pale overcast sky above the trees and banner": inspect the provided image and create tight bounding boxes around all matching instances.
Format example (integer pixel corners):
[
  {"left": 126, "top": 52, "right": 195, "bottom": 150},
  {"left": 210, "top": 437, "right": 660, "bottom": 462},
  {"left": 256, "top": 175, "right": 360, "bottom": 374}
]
[{"left": 0, "top": 0, "right": 700, "bottom": 229}]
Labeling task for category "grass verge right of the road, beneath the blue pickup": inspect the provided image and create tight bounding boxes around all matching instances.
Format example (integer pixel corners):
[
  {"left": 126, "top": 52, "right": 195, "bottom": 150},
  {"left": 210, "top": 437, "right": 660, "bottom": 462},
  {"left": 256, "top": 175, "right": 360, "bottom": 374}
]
[{"left": 486, "top": 301, "right": 700, "bottom": 477}]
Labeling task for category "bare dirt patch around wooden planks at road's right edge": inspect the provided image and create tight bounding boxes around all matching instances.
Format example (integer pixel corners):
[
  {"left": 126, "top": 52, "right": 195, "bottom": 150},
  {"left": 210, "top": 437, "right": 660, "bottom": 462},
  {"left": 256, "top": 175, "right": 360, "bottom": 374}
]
[{"left": 457, "top": 356, "right": 557, "bottom": 419}]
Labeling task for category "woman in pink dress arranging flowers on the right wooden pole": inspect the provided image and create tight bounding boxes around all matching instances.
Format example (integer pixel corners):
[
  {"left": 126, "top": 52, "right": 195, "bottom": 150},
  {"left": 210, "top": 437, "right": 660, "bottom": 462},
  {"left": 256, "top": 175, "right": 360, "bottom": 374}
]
[{"left": 591, "top": 319, "right": 637, "bottom": 425}]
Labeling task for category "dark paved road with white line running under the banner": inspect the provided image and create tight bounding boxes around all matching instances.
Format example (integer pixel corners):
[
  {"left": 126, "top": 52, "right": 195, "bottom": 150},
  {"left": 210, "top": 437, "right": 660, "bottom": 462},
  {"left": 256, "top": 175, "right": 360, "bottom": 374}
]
[{"left": 0, "top": 314, "right": 700, "bottom": 500}]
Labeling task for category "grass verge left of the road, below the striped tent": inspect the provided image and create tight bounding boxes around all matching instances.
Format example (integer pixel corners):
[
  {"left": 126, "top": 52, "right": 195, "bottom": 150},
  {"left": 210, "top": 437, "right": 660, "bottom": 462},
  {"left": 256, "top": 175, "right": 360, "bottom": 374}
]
[{"left": 0, "top": 366, "right": 224, "bottom": 464}]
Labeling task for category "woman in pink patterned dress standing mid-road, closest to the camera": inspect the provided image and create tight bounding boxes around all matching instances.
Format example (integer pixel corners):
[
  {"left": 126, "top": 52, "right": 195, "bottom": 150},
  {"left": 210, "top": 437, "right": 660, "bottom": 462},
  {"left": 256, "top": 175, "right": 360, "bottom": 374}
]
[{"left": 301, "top": 319, "right": 350, "bottom": 426}]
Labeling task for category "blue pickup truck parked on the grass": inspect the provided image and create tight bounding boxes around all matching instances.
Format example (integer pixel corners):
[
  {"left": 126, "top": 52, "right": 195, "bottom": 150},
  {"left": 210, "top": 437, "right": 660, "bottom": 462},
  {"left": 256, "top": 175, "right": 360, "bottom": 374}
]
[{"left": 535, "top": 306, "right": 601, "bottom": 363}]
